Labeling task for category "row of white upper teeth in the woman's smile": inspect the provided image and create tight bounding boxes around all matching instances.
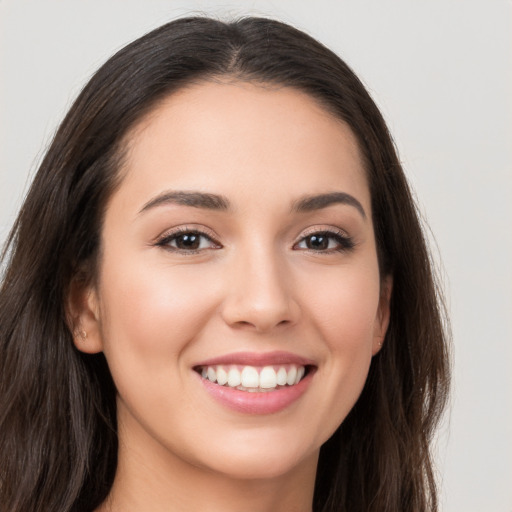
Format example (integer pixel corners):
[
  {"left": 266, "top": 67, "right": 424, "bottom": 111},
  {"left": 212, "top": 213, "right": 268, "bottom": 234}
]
[{"left": 201, "top": 364, "right": 306, "bottom": 392}]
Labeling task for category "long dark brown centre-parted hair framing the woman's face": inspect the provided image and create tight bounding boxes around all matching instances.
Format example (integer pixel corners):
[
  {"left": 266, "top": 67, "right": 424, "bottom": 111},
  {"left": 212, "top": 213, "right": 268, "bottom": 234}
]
[{"left": 0, "top": 18, "right": 449, "bottom": 512}]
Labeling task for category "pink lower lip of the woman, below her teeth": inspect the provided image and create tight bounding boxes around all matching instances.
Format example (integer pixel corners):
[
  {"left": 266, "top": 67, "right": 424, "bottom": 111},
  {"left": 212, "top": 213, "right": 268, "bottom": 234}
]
[{"left": 196, "top": 372, "right": 313, "bottom": 414}]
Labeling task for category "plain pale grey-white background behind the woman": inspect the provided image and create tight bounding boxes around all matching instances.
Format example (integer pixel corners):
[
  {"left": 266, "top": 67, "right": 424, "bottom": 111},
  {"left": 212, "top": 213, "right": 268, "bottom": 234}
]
[{"left": 0, "top": 0, "right": 512, "bottom": 512}]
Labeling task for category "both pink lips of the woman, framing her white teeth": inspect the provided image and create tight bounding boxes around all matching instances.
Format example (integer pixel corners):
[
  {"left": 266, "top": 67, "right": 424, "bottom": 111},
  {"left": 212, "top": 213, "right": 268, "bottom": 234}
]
[{"left": 194, "top": 352, "right": 316, "bottom": 414}]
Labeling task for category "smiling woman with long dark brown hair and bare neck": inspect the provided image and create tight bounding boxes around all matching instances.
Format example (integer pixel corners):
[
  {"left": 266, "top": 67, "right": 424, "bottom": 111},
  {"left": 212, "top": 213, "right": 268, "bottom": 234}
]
[{"left": 0, "top": 18, "right": 448, "bottom": 512}]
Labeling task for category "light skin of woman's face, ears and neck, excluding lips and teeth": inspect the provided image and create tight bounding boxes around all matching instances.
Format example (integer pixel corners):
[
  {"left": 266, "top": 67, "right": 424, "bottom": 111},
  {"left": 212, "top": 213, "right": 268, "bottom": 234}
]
[{"left": 70, "top": 81, "right": 391, "bottom": 512}]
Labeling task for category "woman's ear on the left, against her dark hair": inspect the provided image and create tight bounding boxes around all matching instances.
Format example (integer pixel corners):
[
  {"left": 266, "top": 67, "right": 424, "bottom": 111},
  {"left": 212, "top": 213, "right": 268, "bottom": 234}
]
[{"left": 66, "top": 278, "right": 103, "bottom": 354}]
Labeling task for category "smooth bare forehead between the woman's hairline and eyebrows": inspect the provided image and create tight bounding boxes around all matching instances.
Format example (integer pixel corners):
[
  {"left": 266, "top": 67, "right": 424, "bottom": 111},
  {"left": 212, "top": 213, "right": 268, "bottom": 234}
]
[{"left": 115, "top": 82, "right": 370, "bottom": 211}]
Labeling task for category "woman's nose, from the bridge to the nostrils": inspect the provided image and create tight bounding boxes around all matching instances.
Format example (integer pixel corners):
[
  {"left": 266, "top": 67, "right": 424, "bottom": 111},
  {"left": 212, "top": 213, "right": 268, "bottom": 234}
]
[{"left": 222, "top": 246, "right": 300, "bottom": 333}]
